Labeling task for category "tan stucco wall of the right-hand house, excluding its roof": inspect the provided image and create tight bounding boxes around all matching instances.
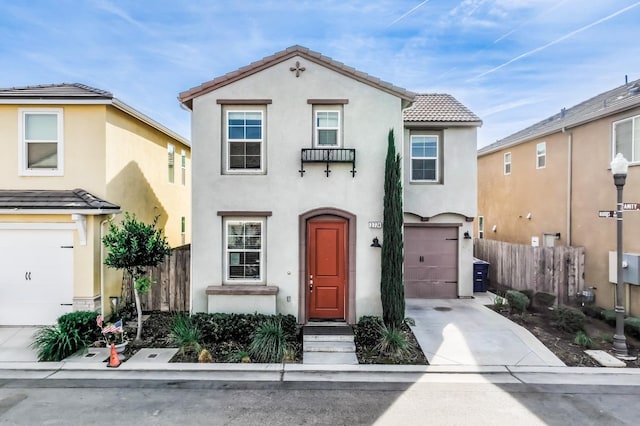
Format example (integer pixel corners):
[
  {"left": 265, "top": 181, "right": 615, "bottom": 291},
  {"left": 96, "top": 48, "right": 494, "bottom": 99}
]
[{"left": 474, "top": 109, "right": 640, "bottom": 316}]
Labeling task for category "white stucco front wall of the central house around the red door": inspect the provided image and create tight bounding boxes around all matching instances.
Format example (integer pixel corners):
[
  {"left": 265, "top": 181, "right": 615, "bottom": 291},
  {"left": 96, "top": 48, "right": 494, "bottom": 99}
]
[{"left": 192, "top": 58, "right": 402, "bottom": 318}]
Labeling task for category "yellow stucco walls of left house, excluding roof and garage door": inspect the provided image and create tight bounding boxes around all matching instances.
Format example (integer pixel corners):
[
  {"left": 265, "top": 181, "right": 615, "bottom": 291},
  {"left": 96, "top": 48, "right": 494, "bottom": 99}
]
[{"left": 0, "top": 105, "right": 191, "bottom": 316}]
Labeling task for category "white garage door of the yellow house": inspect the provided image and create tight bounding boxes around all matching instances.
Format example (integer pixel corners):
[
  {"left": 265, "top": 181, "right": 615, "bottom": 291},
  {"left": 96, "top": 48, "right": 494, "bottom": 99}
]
[{"left": 0, "top": 229, "right": 73, "bottom": 325}]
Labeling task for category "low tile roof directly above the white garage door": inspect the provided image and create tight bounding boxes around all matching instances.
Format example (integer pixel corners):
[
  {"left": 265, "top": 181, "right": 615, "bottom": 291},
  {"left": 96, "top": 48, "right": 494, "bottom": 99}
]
[{"left": 0, "top": 189, "right": 120, "bottom": 211}]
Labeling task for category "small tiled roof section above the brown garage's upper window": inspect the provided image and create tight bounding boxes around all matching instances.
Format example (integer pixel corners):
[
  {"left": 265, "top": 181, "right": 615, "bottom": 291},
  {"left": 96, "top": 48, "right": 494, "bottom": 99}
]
[{"left": 404, "top": 93, "right": 482, "bottom": 126}]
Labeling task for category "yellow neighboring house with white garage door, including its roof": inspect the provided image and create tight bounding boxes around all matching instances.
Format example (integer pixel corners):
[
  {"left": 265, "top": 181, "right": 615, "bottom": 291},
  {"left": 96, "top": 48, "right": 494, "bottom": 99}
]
[{"left": 0, "top": 84, "right": 191, "bottom": 325}]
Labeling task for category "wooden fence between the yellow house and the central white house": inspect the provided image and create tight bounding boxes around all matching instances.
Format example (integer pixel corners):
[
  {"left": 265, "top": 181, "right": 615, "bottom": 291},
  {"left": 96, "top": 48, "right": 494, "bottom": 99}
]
[{"left": 123, "top": 244, "right": 191, "bottom": 312}]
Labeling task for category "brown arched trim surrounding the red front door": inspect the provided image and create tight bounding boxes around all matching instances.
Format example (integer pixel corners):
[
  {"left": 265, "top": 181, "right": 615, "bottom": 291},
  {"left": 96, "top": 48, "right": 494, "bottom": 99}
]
[{"left": 298, "top": 207, "right": 357, "bottom": 324}]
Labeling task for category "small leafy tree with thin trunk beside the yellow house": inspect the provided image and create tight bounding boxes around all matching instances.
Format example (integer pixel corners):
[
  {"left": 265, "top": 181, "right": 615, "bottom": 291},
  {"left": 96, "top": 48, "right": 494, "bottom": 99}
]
[{"left": 102, "top": 213, "right": 171, "bottom": 341}]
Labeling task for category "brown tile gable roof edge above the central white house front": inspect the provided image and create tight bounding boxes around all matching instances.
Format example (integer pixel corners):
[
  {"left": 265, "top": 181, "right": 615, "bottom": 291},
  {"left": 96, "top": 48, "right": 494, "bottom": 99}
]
[{"left": 178, "top": 45, "right": 415, "bottom": 109}]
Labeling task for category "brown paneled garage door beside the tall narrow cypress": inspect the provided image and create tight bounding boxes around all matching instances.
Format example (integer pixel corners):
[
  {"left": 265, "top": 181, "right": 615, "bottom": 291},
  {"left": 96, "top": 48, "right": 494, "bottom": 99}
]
[{"left": 404, "top": 226, "right": 458, "bottom": 299}]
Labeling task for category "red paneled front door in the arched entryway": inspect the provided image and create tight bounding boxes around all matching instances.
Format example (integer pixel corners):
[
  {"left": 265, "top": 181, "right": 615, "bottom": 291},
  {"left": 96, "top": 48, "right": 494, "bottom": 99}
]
[{"left": 307, "top": 221, "right": 348, "bottom": 319}]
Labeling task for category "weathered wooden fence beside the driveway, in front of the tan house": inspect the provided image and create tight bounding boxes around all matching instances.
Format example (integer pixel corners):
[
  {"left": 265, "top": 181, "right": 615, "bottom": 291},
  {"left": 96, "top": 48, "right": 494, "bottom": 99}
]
[{"left": 473, "top": 239, "right": 584, "bottom": 304}]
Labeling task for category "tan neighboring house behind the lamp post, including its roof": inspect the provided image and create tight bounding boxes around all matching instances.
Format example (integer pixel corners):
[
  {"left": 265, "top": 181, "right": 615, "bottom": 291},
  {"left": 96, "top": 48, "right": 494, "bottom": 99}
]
[{"left": 476, "top": 80, "right": 640, "bottom": 315}]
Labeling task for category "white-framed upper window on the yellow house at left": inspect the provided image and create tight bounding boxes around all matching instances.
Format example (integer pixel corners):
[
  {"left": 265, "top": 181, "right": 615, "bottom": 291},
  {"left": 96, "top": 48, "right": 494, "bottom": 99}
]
[{"left": 18, "top": 108, "right": 64, "bottom": 176}]
